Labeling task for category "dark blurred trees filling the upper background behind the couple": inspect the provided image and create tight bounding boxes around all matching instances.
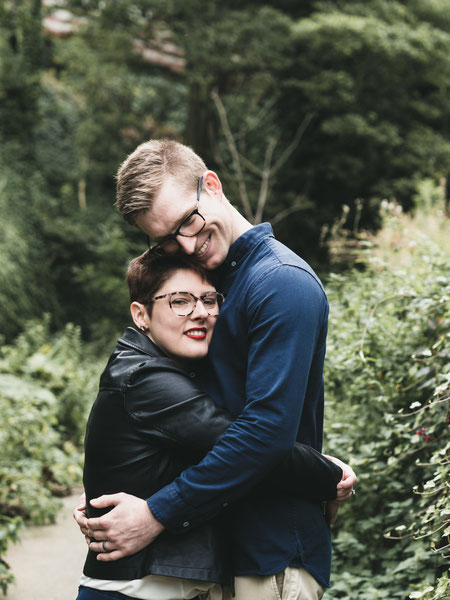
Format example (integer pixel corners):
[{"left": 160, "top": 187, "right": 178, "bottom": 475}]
[{"left": 0, "top": 0, "right": 450, "bottom": 339}]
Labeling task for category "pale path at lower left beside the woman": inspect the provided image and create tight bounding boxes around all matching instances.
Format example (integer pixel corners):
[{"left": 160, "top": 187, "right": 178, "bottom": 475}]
[{"left": 5, "top": 494, "right": 87, "bottom": 600}]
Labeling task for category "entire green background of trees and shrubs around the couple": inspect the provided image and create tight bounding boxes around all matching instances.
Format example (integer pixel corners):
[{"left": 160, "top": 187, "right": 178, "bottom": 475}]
[{"left": 0, "top": 0, "right": 450, "bottom": 600}]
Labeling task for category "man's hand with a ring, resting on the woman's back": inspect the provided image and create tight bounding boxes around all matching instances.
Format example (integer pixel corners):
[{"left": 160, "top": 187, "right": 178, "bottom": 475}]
[{"left": 74, "top": 492, "right": 165, "bottom": 562}]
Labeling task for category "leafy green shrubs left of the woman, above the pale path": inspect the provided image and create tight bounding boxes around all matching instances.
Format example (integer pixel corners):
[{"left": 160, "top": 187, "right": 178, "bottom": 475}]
[{"left": 0, "top": 319, "right": 103, "bottom": 591}]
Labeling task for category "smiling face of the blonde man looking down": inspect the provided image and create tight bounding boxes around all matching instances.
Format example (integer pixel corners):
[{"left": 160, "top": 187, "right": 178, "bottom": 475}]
[{"left": 136, "top": 171, "right": 234, "bottom": 270}]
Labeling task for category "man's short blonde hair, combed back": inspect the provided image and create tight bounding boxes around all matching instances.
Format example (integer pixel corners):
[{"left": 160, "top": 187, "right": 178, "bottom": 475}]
[{"left": 115, "top": 140, "right": 206, "bottom": 224}]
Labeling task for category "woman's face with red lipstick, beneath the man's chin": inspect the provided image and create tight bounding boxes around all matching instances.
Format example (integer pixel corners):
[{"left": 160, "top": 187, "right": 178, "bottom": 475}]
[{"left": 145, "top": 270, "right": 217, "bottom": 359}]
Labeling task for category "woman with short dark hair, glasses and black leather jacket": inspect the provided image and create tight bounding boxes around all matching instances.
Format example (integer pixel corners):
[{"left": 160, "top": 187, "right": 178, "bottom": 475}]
[{"left": 78, "top": 252, "right": 342, "bottom": 600}]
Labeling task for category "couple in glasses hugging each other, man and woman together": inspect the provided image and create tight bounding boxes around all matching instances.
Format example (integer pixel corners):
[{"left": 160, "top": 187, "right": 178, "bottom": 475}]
[{"left": 74, "top": 140, "right": 356, "bottom": 600}]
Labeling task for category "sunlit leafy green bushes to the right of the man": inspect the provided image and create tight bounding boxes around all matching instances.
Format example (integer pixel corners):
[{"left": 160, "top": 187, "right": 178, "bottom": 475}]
[{"left": 325, "top": 186, "right": 450, "bottom": 600}]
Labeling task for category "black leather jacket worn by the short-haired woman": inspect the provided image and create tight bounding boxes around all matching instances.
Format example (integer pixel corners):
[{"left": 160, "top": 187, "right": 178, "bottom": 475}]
[{"left": 84, "top": 327, "right": 342, "bottom": 583}]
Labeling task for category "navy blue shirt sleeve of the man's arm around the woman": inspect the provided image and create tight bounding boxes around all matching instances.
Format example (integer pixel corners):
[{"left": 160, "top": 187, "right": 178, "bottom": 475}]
[{"left": 147, "top": 265, "right": 328, "bottom": 532}]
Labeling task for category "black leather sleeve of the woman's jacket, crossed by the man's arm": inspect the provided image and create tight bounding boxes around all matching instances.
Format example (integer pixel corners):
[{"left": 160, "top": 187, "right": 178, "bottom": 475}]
[{"left": 123, "top": 358, "right": 342, "bottom": 500}]
